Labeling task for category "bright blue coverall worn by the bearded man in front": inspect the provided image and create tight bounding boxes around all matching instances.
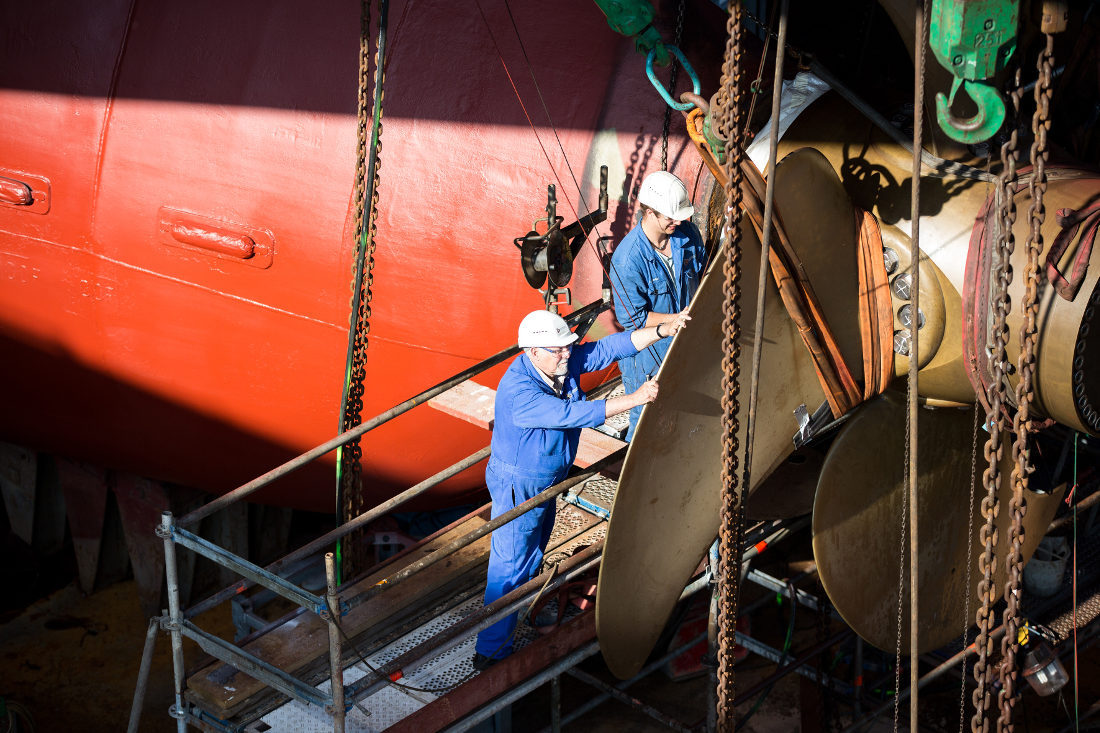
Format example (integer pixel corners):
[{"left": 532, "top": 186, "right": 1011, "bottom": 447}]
[{"left": 476, "top": 333, "right": 637, "bottom": 659}]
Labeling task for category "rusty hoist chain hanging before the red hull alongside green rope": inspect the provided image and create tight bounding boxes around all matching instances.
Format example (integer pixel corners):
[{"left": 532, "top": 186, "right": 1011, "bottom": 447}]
[{"left": 338, "top": 0, "right": 388, "bottom": 577}]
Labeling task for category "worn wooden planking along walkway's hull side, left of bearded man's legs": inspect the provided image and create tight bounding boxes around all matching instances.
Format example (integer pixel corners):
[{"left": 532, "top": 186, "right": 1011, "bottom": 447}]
[{"left": 187, "top": 512, "right": 490, "bottom": 718}]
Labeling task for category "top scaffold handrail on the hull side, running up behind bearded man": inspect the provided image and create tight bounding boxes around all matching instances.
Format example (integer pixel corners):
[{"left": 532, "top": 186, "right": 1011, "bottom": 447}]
[{"left": 179, "top": 300, "right": 607, "bottom": 525}]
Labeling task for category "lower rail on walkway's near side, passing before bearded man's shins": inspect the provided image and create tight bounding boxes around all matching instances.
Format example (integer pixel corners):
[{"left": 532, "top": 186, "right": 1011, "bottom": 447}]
[{"left": 344, "top": 539, "right": 604, "bottom": 701}]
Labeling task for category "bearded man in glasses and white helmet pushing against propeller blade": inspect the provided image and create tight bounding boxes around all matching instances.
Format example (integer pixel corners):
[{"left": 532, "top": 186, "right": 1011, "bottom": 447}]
[{"left": 473, "top": 310, "right": 686, "bottom": 670}]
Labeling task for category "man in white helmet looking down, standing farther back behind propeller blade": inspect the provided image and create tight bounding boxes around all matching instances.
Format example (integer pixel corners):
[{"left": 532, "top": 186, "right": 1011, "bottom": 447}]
[{"left": 611, "top": 171, "right": 706, "bottom": 440}]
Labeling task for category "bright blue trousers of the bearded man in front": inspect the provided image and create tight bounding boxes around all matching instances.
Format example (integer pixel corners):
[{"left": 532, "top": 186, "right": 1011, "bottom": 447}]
[{"left": 476, "top": 459, "right": 565, "bottom": 659}]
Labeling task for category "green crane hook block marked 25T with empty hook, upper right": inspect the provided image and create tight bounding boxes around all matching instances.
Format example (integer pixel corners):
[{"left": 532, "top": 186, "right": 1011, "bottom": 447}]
[{"left": 928, "top": 0, "right": 1020, "bottom": 143}]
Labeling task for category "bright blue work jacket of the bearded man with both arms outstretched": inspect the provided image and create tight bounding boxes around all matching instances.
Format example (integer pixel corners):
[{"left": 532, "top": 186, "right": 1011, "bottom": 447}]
[{"left": 490, "top": 332, "right": 638, "bottom": 479}]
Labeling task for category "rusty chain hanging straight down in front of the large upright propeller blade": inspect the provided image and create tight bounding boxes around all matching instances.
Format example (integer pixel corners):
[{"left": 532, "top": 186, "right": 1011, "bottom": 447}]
[{"left": 716, "top": 1, "right": 745, "bottom": 732}]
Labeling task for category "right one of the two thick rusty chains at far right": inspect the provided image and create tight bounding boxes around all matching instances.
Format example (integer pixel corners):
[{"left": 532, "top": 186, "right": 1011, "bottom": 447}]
[{"left": 997, "top": 25, "right": 1054, "bottom": 731}]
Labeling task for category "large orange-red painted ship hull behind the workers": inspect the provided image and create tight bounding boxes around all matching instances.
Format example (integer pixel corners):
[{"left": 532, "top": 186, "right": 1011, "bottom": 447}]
[{"left": 0, "top": 0, "right": 722, "bottom": 511}]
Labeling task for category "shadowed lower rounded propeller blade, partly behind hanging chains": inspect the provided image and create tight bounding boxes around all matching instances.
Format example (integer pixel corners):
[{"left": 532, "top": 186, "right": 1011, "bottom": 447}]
[{"left": 813, "top": 392, "right": 1064, "bottom": 654}]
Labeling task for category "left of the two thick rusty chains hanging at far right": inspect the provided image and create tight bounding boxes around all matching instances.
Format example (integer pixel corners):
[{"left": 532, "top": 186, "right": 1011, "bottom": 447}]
[{"left": 970, "top": 72, "right": 1021, "bottom": 733}]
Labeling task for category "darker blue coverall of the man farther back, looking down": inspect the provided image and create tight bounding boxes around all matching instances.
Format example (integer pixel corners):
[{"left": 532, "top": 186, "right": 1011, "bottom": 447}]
[{"left": 611, "top": 221, "right": 707, "bottom": 440}]
